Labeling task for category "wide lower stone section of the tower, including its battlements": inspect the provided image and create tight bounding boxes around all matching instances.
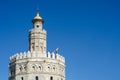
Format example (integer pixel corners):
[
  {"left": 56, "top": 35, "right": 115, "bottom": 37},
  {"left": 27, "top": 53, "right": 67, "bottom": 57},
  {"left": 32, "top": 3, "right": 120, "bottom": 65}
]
[{"left": 9, "top": 52, "right": 65, "bottom": 80}]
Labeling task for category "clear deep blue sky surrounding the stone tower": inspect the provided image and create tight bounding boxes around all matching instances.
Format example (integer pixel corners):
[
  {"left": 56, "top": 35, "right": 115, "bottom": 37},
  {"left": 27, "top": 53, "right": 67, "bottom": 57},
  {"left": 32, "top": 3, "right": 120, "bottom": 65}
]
[{"left": 0, "top": 0, "right": 120, "bottom": 80}]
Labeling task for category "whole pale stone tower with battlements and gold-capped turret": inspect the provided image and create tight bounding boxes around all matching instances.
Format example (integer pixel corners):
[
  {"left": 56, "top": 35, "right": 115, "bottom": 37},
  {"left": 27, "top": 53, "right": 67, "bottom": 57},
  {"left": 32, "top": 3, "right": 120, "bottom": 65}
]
[{"left": 9, "top": 12, "right": 65, "bottom": 80}]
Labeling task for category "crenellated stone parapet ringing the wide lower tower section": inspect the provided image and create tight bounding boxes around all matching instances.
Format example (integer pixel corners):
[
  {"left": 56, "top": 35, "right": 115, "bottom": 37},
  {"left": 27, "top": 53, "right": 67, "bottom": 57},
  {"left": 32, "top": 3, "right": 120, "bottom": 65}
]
[{"left": 10, "top": 51, "right": 65, "bottom": 63}]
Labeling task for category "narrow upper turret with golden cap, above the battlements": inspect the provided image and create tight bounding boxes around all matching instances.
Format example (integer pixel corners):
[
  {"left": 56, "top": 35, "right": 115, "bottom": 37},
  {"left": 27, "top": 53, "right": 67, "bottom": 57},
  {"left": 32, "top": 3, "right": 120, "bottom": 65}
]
[{"left": 29, "top": 12, "right": 46, "bottom": 53}]
